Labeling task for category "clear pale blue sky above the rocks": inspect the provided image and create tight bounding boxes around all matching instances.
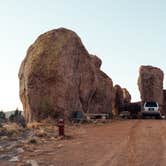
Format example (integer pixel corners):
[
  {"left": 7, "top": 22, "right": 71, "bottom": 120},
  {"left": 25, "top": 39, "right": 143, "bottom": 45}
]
[{"left": 0, "top": 0, "right": 166, "bottom": 111}]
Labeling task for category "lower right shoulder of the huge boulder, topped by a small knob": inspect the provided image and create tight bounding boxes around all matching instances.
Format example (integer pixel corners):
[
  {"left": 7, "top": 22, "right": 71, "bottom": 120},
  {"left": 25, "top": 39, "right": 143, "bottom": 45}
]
[{"left": 88, "top": 56, "right": 114, "bottom": 113}]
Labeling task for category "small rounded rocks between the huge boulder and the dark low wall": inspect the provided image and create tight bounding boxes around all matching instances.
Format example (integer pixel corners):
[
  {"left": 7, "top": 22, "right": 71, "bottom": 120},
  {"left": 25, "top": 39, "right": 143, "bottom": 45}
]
[{"left": 113, "top": 85, "right": 131, "bottom": 116}]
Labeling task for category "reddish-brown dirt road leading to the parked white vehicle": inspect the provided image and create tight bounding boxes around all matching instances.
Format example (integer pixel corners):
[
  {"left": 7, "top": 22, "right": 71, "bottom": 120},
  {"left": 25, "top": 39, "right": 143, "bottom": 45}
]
[{"left": 22, "top": 120, "right": 166, "bottom": 166}]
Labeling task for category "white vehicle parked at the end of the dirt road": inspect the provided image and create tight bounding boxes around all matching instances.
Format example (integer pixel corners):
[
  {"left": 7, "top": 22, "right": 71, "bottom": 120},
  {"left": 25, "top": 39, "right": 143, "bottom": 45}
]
[{"left": 142, "top": 101, "right": 161, "bottom": 118}]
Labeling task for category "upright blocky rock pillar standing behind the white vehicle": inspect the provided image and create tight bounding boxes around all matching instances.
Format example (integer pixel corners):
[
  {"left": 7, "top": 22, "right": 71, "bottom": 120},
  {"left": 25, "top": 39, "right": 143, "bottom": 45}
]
[{"left": 138, "top": 66, "right": 164, "bottom": 108}]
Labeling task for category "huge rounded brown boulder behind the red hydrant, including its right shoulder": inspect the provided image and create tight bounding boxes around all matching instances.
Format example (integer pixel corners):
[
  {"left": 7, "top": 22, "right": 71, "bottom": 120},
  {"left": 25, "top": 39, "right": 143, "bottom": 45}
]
[{"left": 19, "top": 28, "right": 114, "bottom": 122}]
